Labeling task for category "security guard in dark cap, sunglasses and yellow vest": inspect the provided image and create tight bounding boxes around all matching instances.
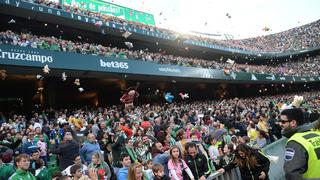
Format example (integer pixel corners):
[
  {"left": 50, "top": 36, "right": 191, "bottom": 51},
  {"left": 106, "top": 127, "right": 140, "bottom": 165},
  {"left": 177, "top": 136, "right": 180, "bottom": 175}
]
[{"left": 280, "top": 108, "right": 320, "bottom": 180}]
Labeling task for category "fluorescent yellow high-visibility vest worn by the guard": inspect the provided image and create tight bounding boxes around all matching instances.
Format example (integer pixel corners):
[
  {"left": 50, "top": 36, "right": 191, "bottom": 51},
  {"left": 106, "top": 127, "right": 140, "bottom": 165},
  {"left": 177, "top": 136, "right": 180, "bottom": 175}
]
[{"left": 288, "top": 131, "right": 320, "bottom": 179}]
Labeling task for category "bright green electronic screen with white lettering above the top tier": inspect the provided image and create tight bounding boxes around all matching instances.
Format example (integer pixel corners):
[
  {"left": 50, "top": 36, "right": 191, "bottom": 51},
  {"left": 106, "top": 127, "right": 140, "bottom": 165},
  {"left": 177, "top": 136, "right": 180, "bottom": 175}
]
[{"left": 62, "top": 0, "right": 155, "bottom": 26}]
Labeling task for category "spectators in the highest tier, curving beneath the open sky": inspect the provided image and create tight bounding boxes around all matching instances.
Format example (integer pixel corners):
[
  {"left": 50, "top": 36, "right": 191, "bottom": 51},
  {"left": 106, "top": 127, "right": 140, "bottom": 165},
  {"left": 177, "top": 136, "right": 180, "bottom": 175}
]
[{"left": 3, "top": 0, "right": 320, "bottom": 53}]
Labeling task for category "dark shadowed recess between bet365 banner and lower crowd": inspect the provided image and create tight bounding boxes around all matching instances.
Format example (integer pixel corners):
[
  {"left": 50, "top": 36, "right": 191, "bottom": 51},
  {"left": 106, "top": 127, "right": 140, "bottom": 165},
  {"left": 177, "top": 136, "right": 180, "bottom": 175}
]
[{"left": 0, "top": 66, "right": 320, "bottom": 115}]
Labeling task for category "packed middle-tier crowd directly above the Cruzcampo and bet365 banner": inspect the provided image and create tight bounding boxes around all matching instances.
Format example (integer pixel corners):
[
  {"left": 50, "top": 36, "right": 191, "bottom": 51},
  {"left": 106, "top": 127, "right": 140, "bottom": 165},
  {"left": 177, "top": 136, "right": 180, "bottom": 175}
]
[{"left": 0, "top": 30, "right": 320, "bottom": 76}]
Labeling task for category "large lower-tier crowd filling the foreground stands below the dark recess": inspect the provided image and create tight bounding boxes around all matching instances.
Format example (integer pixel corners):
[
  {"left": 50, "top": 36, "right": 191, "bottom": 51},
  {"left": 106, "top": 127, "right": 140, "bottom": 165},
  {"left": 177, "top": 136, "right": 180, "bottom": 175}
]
[{"left": 0, "top": 92, "right": 320, "bottom": 180}]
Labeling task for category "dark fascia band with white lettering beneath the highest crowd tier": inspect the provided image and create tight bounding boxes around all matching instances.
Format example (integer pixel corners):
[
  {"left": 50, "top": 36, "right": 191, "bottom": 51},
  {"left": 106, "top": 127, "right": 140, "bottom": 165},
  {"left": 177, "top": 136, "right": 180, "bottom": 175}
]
[{"left": 0, "top": 1, "right": 320, "bottom": 63}]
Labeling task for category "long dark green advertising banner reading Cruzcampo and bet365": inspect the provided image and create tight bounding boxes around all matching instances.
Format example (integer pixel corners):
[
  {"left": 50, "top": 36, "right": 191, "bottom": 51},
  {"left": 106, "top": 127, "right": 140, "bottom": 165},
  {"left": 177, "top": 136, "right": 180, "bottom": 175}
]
[{"left": 0, "top": 45, "right": 320, "bottom": 83}]
